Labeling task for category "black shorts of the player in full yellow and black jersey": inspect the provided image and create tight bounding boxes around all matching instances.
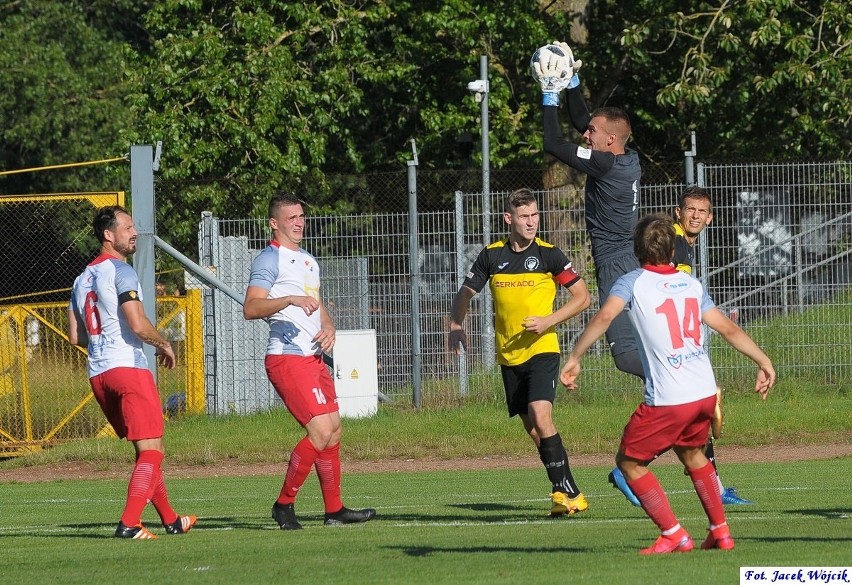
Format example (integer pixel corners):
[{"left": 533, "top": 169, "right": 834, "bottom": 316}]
[{"left": 500, "top": 353, "right": 559, "bottom": 417}]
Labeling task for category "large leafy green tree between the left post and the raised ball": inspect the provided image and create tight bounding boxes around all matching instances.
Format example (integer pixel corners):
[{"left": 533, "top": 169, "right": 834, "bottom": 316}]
[{"left": 121, "top": 0, "right": 562, "bottom": 253}]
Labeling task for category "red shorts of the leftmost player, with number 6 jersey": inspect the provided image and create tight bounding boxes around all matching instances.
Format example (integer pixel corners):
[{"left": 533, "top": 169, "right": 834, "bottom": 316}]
[{"left": 89, "top": 368, "right": 163, "bottom": 441}]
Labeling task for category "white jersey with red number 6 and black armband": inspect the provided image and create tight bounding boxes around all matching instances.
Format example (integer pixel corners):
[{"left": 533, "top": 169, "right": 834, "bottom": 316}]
[{"left": 71, "top": 254, "right": 148, "bottom": 378}]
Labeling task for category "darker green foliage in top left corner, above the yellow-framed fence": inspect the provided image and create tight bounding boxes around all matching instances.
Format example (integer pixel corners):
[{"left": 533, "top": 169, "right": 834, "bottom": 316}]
[{"left": 0, "top": 0, "right": 148, "bottom": 193}]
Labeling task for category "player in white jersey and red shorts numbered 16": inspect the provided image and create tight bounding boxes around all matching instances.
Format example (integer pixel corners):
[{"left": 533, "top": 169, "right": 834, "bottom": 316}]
[{"left": 243, "top": 194, "right": 376, "bottom": 530}]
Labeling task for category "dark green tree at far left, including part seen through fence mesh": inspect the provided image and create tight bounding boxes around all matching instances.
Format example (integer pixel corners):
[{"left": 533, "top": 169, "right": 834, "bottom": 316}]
[{"left": 0, "top": 0, "right": 144, "bottom": 297}]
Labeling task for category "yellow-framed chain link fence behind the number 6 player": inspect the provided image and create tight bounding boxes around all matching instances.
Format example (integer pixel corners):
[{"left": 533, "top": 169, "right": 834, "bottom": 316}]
[{"left": 0, "top": 192, "right": 203, "bottom": 456}]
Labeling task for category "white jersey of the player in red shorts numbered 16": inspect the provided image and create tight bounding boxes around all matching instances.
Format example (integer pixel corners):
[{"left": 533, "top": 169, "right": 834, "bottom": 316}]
[{"left": 249, "top": 241, "right": 322, "bottom": 356}]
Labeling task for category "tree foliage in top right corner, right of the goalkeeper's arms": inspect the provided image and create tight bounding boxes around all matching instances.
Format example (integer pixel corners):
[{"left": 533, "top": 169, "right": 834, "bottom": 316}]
[{"left": 585, "top": 0, "right": 852, "bottom": 160}]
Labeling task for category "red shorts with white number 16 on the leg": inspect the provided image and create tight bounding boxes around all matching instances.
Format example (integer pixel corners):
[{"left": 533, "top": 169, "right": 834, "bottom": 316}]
[{"left": 265, "top": 355, "right": 339, "bottom": 426}]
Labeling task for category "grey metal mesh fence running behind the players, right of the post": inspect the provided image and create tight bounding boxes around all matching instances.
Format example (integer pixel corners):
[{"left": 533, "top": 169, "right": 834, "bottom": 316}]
[{"left": 202, "top": 162, "right": 852, "bottom": 406}]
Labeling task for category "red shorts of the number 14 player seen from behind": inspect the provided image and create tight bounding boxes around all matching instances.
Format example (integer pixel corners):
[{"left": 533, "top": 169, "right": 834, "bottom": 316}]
[{"left": 620, "top": 395, "right": 716, "bottom": 461}]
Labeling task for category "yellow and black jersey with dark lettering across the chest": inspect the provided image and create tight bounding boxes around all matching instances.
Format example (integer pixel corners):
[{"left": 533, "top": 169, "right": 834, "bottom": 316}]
[{"left": 464, "top": 238, "right": 580, "bottom": 366}]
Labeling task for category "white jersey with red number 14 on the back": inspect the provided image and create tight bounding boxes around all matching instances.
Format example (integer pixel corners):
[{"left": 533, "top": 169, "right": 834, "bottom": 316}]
[{"left": 610, "top": 266, "right": 716, "bottom": 406}]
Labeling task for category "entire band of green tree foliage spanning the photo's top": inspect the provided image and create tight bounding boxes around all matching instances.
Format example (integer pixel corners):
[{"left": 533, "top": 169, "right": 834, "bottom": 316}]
[{"left": 0, "top": 0, "right": 852, "bottom": 237}]
